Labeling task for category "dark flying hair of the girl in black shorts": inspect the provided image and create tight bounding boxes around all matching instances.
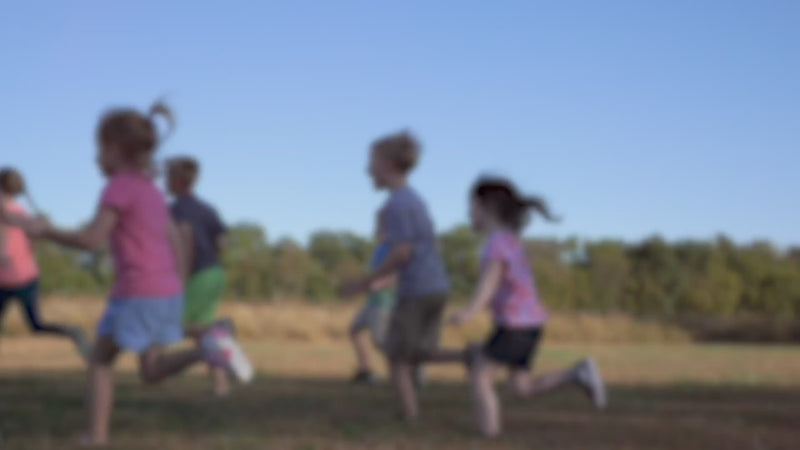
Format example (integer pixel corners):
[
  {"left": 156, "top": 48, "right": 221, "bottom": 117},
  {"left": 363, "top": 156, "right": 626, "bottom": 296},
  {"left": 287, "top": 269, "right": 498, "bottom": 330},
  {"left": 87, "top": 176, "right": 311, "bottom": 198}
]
[{"left": 472, "top": 177, "right": 559, "bottom": 231}]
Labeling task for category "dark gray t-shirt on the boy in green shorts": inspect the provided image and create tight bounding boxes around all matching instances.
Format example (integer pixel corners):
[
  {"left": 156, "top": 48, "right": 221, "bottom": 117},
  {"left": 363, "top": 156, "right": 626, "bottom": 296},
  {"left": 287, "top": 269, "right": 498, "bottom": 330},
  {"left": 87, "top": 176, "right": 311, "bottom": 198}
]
[{"left": 170, "top": 195, "right": 227, "bottom": 274}]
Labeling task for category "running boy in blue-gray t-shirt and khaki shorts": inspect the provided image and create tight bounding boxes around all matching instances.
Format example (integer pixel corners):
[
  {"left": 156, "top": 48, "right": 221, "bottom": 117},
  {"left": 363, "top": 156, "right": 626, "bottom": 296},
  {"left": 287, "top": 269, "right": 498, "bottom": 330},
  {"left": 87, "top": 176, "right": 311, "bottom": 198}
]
[{"left": 342, "top": 133, "right": 450, "bottom": 421}]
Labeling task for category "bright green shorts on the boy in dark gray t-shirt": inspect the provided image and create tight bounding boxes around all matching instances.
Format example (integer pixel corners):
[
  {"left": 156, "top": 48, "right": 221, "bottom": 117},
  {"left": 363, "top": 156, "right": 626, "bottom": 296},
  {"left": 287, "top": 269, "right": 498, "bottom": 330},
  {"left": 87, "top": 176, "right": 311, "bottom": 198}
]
[{"left": 183, "top": 266, "right": 225, "bottom": 325}]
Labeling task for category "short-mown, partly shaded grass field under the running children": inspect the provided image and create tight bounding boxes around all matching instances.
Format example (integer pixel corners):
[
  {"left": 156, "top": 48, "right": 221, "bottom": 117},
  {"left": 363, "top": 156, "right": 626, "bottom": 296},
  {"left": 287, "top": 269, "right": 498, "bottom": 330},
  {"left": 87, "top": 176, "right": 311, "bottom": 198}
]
[{"left": 0, "top": 337, "right": 800, "bottom": 450}]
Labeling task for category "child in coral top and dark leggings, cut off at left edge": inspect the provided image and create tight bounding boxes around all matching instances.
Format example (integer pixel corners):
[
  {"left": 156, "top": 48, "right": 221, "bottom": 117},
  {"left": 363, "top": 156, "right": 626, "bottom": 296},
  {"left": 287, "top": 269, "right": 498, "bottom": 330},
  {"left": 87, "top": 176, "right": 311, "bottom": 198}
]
[{"left": 0, "top": 168, "right": 91, "bottom": 359}]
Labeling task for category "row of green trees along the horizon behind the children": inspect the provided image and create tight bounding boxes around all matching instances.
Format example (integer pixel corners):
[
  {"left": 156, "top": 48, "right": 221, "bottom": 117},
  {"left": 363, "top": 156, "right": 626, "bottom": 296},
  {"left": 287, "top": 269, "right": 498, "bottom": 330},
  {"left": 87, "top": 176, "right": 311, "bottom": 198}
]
[{"left": 36, "top": 224, "right": 800, "bottom": 319}]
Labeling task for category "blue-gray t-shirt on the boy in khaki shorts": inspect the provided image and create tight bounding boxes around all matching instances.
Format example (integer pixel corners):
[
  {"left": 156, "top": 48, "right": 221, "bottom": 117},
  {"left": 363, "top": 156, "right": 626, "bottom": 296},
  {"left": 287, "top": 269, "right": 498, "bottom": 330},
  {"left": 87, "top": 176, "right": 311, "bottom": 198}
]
[{"left": 383, "top": 187, "right": 450, "bottom": 299}]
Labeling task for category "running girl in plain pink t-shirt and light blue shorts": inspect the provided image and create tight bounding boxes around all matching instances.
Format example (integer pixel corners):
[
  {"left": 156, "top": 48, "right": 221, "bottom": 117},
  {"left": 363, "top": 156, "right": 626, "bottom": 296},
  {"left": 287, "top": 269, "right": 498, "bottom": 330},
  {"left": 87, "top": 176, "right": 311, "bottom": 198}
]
[{"left": 43, "top": 103, "right": 252, "bottom": 445}]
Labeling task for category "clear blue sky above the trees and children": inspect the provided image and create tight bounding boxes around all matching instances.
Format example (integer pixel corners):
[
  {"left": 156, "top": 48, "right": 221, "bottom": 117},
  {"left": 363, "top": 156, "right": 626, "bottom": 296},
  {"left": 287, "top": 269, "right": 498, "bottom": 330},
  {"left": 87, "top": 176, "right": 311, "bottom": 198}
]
[{"left": 0, "top": 0, "right": 800, "bottom": 245}]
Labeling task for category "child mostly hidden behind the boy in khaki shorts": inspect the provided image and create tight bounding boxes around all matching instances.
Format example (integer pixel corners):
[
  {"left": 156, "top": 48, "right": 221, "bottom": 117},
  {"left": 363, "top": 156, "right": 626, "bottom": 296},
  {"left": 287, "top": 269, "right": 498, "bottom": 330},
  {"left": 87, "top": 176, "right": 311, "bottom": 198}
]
[{"left": 350, "top": 213, "right": 396, "bottom": 384}]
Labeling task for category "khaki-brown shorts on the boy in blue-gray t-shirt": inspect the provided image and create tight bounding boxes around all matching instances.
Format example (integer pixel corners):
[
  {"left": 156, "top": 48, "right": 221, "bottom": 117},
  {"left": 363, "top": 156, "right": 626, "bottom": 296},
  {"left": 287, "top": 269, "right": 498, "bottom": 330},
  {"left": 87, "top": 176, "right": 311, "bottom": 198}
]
[{"left": 386, "top": 294, "right": 447, "bottom": 362}]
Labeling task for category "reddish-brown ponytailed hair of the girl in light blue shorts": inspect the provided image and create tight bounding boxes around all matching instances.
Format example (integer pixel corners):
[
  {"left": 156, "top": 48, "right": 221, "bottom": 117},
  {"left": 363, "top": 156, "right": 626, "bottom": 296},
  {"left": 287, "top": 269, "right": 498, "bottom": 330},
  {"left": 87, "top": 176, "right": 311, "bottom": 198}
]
[{"left": 97, "top": 101, "right": 175, "bottom": 163}]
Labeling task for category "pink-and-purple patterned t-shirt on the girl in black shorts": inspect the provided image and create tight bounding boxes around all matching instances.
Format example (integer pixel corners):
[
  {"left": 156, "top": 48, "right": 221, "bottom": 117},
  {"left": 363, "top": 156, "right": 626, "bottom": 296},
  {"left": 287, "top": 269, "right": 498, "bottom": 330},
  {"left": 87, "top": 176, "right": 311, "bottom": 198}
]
[{"left": 481, "top": 230, "right": 547, "bottom": 328}]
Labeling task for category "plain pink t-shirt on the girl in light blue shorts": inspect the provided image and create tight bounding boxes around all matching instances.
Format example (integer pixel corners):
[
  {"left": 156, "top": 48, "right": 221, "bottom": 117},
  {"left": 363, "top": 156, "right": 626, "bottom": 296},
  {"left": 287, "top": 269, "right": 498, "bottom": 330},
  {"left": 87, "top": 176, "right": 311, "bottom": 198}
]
[{"left": 100, "top": 172, "right": 183, "bottom": 299}]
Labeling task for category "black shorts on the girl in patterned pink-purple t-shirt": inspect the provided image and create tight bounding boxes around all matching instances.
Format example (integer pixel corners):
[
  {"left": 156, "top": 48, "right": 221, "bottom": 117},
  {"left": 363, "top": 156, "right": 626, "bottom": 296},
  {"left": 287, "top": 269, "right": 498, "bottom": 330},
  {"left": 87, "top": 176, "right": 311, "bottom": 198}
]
[{"left": 483, "top": 327, "right": 542, "bottom": 369}]
